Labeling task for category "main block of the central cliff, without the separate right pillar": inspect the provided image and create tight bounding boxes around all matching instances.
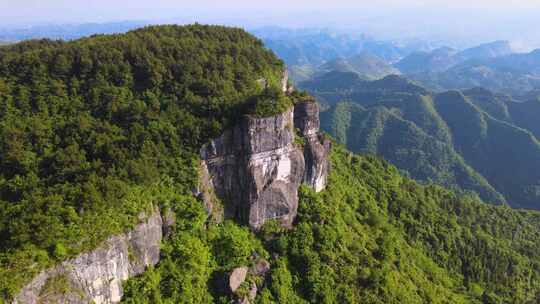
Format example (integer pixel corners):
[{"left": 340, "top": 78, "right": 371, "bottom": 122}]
[{"left": 201, "top": 109, "right": 304, "bottom": 229}]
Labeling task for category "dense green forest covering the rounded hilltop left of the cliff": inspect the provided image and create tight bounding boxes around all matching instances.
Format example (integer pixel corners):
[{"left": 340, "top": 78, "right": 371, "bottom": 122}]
[{"left": 0, "top": 25, "right": 285, "bottom": 299}]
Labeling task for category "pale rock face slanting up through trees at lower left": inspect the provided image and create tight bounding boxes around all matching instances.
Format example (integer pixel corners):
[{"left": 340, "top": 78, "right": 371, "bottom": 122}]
[{"left": 13, "top": 210, "right": 163, "bottom": 304}]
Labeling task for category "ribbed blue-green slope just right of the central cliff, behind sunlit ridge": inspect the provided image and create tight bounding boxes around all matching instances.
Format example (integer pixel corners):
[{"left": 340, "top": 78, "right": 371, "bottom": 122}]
[{"left": 322, "top": 103, "right": 504, "bottom": 203}]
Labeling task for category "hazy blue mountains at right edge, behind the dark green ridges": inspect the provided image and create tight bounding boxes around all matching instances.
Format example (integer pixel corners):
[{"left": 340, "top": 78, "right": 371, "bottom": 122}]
[{"left": 394, "top": 41, "right": 540, "bottom": 95}]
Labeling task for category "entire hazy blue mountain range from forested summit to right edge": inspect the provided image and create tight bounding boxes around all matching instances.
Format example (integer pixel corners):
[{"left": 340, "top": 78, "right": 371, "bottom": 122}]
[{"left": 254, "top": 28, "right": 540, "bottom": 97}]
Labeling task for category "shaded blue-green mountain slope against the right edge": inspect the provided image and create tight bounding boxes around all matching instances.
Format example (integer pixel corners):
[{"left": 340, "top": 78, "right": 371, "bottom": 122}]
[{"left": 435, "top": 92, "right": 540, "bottom": 208}]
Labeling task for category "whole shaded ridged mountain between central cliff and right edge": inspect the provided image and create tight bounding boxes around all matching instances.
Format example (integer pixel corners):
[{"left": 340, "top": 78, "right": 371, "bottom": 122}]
[{"left": 302, "top": 72, "right": 540, "bottom": 209}]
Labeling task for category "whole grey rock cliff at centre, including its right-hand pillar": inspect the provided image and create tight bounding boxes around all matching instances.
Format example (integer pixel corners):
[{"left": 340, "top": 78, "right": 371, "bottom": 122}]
[{"left": 201, "top": 102, "right": 329, "bottom": 229}]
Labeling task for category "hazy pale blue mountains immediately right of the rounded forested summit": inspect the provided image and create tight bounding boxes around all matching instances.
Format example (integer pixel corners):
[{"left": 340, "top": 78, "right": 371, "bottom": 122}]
[{"left": 253, "top": 28, "right": 433, "bottom": 81}]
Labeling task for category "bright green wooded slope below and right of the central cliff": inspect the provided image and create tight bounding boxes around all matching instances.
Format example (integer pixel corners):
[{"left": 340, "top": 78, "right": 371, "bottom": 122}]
[{"left": 124, "top": 147, "right": 540, "bottom": 304}]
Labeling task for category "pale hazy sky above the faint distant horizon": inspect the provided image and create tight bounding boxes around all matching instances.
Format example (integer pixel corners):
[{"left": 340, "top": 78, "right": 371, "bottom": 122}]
[{"left": 0, "top": 0, "right": 540, "bottom": 23}]
